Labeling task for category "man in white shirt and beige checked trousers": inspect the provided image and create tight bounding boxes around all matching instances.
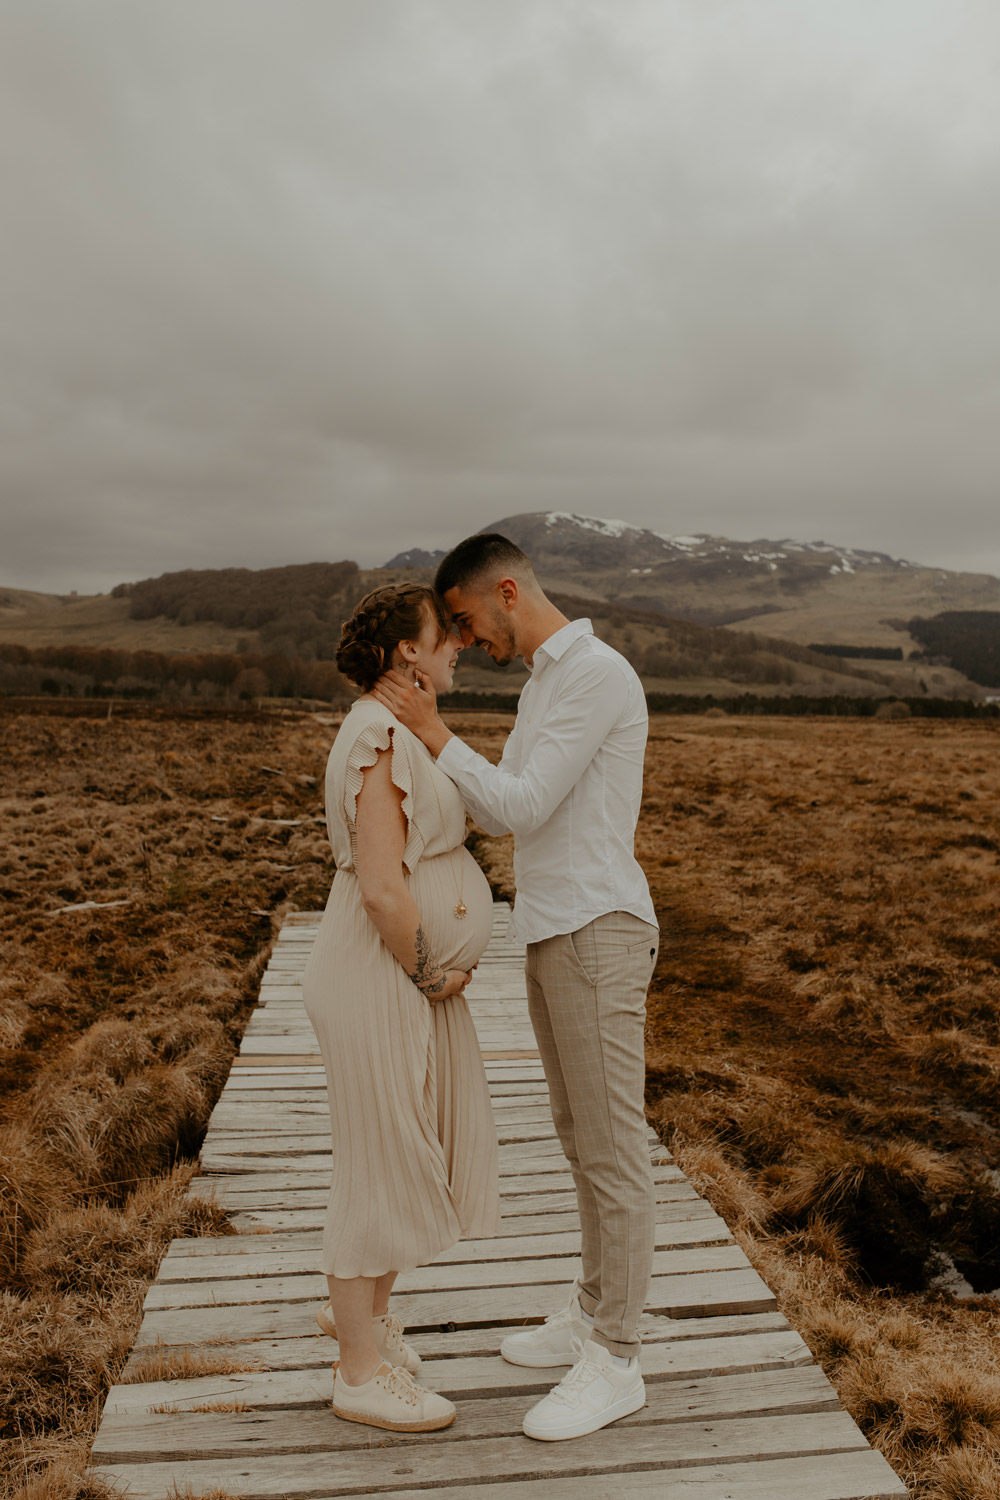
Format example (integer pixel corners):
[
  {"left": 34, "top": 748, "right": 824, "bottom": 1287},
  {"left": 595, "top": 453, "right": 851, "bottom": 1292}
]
[{"left": 376, "top": 534, "right": 658, "bottom": 1440}]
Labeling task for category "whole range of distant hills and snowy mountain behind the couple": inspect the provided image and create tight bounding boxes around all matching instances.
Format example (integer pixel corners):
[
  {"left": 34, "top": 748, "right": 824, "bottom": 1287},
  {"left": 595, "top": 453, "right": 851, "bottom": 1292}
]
[{"left": 0, "top": 512, "right": 1000, "bottom": 698}]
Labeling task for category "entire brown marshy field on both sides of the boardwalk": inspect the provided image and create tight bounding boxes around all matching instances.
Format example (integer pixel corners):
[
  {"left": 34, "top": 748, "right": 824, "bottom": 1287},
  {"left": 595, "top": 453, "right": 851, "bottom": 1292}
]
[{"left": 0, "top": 699, "right": 1000, "bottom": 1500}]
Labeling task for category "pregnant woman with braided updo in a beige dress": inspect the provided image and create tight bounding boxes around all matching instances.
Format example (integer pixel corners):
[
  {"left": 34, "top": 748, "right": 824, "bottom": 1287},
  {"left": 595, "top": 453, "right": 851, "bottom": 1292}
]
[{"left": 303, "top": 584, "right": 499, "bottom": 1433}]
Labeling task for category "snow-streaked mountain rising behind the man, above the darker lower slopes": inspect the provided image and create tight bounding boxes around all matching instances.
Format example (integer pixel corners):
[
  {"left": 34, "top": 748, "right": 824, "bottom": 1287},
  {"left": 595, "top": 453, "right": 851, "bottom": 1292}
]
[{"left": 383, "top": 510, "right": 1000, "bottom": 656}]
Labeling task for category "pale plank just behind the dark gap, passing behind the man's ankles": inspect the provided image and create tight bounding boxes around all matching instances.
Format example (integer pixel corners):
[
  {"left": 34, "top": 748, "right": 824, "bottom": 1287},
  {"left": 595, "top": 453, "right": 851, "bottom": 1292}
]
[{"left": 136, "top": 1269, "right": 775, "bottom": 1347}]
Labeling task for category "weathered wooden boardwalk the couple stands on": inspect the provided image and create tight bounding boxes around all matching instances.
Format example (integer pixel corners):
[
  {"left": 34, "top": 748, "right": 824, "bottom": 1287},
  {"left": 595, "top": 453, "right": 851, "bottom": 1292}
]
[{"left": 93, "top": 906, "right": 907, "bottom": 1500}]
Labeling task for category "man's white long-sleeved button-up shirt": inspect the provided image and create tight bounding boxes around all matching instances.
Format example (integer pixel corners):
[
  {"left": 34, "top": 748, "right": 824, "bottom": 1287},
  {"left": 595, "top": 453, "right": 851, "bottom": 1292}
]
[{"left": 438, "top": 620, "right": 657, "bottom": 942}]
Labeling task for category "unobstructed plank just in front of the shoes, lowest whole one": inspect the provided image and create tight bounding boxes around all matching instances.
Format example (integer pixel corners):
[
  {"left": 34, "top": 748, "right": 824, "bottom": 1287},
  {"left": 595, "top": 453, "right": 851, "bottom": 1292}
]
[{"left": 89, "top": 1412, "right": 868, "bottom": 1500}]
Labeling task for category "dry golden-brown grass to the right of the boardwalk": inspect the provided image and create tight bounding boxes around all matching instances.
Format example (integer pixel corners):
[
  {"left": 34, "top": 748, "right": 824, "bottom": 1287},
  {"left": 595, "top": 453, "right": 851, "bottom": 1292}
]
[{"left": 471, "top": 716, "right": 1000, "bottom": 1500}]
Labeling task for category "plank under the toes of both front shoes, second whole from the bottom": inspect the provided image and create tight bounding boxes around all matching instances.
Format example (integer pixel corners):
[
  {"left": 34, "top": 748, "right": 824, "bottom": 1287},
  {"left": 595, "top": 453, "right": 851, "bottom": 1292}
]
[{"left": 93, "top": 1365, "right": 838, "bottom": 1464}]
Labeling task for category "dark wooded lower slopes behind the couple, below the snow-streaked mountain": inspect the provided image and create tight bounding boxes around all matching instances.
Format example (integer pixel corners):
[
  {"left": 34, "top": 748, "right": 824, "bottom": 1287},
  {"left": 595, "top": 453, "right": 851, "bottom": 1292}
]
[{"left": 0, "top": 561, "right": 1000, "bottom": 704}]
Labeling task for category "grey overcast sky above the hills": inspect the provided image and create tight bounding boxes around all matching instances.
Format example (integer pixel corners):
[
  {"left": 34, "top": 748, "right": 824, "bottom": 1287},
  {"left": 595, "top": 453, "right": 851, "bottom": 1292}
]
[{"left": 0, "top": 0, "right": 1000, "bottom": 593}]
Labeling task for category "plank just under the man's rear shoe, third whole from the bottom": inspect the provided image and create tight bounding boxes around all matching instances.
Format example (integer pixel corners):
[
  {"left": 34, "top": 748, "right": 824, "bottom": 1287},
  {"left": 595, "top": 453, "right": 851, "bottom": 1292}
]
[{"left": 106, "top": 1329, "right": 825, "bottom": 1418}]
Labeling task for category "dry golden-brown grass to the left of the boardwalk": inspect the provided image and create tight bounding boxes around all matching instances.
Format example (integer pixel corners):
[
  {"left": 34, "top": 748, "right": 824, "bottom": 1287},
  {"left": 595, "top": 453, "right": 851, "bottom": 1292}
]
[{"left": 0, "top": 702, "right": 340, "bottom": 1500}]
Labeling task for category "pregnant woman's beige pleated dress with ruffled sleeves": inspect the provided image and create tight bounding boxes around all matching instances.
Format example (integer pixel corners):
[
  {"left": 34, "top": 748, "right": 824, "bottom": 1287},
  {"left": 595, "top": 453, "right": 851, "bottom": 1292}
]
[{"left": 303, "top": 699, "right": 499, "bottom": 1278}]
